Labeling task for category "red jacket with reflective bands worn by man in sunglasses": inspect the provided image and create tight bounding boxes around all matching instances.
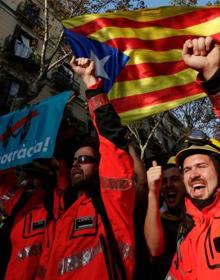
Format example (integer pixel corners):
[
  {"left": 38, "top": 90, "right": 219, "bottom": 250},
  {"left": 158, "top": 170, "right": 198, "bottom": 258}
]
[{"left": 37, "top": 94, "right": 135, "bottom": 280}]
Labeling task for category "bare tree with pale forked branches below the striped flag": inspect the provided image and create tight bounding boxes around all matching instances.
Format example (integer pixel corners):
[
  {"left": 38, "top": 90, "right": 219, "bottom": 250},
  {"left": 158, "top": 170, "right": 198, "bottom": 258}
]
[{"left": 127, "top": 111, "right": 187, "bottom": 163}]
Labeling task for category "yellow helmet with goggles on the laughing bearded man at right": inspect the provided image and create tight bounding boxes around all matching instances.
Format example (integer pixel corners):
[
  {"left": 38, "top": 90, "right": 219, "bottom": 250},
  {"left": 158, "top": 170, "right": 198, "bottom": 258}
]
[{"left": 176, "top": 130, "right": 220, "bottom": 168}]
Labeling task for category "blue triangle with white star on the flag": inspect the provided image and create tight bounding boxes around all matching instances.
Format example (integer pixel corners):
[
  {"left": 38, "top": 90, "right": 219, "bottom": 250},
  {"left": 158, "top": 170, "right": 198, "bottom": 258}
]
[{"left": 64, "top": 29, "right": 129, "bottom": 93}]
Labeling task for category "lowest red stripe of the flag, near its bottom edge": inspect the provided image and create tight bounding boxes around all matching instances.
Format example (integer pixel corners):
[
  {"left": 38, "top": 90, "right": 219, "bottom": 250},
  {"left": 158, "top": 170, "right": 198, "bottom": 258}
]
[{"left": 111, "top": 82, "right": 202, "bottom": 113}]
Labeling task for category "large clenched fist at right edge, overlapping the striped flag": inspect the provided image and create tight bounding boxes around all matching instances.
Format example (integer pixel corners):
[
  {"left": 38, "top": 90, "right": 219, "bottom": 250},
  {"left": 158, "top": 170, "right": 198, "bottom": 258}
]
[{"left": 182, "top": 37, "right": 220, "bottom": 80}]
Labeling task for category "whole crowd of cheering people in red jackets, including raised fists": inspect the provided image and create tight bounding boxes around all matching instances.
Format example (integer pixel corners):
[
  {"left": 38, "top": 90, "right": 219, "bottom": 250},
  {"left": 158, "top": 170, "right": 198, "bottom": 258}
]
[{"left": 0, "top": 37, "right": 220, "bottom": 280}]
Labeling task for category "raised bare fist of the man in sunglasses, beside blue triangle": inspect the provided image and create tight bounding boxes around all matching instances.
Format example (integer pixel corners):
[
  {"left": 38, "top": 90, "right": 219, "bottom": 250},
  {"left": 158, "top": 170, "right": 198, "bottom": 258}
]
[{"left": 70, "top": 56, "right": 98, "bottom": 88}]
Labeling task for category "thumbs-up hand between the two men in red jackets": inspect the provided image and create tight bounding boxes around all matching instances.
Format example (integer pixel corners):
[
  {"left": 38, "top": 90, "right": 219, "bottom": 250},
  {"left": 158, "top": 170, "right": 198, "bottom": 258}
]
[{"left": 147, "top": 160, "right": 163, "bottom": 195}]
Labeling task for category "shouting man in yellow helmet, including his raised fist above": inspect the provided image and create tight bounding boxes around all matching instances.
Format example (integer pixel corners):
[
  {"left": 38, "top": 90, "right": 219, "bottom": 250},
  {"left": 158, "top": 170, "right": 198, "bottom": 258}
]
[{"left": 167, "top": 37, "right": 220, "bottom": 280}]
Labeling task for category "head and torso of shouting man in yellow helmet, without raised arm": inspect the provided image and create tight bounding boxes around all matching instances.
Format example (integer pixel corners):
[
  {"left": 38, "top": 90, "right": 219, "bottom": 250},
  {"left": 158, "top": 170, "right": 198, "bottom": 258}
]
[{"left": 166, "top": 130, "right": 220, "bottom": 280}]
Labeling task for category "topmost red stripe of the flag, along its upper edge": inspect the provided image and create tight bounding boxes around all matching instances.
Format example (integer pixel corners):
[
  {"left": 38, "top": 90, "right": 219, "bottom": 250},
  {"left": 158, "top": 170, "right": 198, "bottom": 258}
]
[{"left": 72, "top": 8, "right": 220, "bottom": 36}]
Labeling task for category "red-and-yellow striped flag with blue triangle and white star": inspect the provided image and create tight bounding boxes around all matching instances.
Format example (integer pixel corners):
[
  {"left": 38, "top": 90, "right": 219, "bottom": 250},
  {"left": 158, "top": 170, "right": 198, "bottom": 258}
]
[{"left": 63, "top": 6, "right": 220, "bottom": 123}]
